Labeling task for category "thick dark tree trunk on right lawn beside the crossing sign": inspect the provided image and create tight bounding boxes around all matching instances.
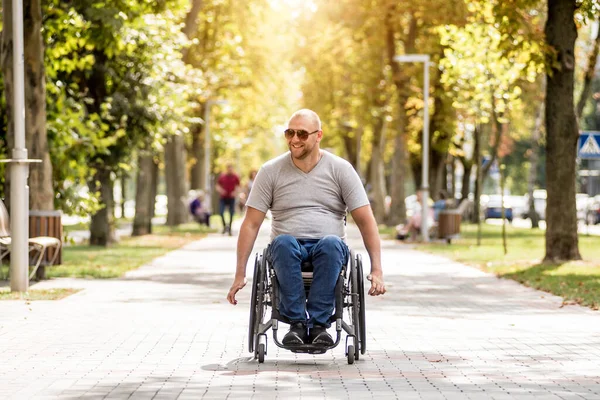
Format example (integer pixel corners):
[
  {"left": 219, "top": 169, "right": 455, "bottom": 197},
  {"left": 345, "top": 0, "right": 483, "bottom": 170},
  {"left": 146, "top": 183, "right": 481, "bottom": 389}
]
[{"left": 544, "top": 0, "right": 581, "bottom": 262}]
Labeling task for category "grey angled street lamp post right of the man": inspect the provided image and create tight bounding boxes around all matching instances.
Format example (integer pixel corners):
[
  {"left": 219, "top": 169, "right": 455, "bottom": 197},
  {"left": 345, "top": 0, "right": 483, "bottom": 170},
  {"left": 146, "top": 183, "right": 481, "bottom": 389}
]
[{"left": 394, "top": 54, "right": 430, "bottom": 242}]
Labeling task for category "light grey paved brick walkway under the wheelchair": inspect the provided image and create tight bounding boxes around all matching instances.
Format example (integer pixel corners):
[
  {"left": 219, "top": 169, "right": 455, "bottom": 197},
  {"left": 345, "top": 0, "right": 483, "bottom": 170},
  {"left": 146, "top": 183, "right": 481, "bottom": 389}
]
[{"left": 0, "top": 220, "right": 600, "bottom": 399}]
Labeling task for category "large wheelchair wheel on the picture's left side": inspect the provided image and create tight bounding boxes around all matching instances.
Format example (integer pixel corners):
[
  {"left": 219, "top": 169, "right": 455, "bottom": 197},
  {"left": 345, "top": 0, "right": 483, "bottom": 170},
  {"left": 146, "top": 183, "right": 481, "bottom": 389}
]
[{"left": 248, "top": 252, "right": 267, "bottom": 354}]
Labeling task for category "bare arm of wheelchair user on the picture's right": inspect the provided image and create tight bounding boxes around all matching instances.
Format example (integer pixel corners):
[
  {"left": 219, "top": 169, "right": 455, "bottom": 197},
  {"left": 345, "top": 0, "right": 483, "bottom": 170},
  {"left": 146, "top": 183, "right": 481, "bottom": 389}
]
[{"left": 350, "top": 205, "right": 385, "bottom": 296}]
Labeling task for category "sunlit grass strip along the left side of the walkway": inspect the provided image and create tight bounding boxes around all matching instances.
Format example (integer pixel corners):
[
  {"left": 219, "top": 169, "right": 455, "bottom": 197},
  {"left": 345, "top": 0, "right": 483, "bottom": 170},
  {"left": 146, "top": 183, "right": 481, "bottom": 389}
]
[{"left": 46, "top": 223, "right": 212, "bottom": 279}]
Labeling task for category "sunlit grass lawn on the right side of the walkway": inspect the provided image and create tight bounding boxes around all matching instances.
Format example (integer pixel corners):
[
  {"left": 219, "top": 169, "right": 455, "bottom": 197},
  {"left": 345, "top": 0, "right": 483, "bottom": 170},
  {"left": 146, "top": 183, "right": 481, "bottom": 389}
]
[{"left": 418, "top": 224, "right": 600, "bottom": 310}]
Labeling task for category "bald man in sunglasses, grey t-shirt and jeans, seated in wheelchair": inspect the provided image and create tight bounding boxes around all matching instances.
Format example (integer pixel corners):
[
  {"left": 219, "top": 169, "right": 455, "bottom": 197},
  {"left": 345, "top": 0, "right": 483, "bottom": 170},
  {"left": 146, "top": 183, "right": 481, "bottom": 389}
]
[{"left": 227, "top": 109, "right": 385, "bottom": 346}]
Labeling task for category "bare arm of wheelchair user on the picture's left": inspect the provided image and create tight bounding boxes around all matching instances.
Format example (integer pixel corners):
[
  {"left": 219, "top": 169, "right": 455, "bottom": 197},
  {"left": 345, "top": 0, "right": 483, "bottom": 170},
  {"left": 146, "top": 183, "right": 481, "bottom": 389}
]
[{"left": 227, "top": 207, "right": 265, "bottom": 305}]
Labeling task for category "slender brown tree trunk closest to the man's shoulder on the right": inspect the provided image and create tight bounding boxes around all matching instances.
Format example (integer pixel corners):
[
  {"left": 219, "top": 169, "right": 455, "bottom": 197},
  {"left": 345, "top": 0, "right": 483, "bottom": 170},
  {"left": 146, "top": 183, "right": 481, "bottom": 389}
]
[{"left": 369, "top": 115, "right": 387, "bottom": 223}]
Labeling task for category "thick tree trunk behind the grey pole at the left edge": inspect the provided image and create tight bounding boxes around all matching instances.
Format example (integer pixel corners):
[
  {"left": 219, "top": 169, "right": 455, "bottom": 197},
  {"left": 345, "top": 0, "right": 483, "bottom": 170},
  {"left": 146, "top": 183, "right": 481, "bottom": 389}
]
[{"left": 1, "top": 0, "right": 54, "bottom": 210}]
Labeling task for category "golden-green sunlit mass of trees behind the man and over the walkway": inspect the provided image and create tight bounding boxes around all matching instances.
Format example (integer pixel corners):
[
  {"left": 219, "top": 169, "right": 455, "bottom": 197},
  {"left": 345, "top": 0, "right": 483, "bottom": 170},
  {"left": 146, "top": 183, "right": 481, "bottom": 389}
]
[{"left": 0, "top": 0, "right": 598, "bottom": 260}]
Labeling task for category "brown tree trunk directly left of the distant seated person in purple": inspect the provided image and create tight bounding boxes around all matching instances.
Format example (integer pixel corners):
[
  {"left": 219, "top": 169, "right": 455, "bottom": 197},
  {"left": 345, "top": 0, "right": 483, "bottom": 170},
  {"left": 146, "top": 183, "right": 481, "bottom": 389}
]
[{"left": 165, "top": 135, "right": 188, "bottom": 226}]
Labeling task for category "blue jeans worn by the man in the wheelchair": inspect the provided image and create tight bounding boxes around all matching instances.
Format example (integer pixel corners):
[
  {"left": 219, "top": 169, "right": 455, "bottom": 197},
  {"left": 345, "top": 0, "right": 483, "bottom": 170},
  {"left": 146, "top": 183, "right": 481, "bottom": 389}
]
[{"left": 269, "top": 235, "right": 349, "bottom": 328}]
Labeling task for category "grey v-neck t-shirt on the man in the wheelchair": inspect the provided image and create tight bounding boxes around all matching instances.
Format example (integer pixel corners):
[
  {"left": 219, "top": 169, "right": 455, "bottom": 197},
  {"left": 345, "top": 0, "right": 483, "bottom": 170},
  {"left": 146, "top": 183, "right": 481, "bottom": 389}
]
[{"left": 246, "top": 150, "right": 369, "bottom": 240}]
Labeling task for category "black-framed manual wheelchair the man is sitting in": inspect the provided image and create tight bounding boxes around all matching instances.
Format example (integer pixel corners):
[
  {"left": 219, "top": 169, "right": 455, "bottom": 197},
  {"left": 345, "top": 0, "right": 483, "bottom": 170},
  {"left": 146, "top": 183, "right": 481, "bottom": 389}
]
[{"left": 248, "top": 249, "right": 366, "bottom": 364}]
